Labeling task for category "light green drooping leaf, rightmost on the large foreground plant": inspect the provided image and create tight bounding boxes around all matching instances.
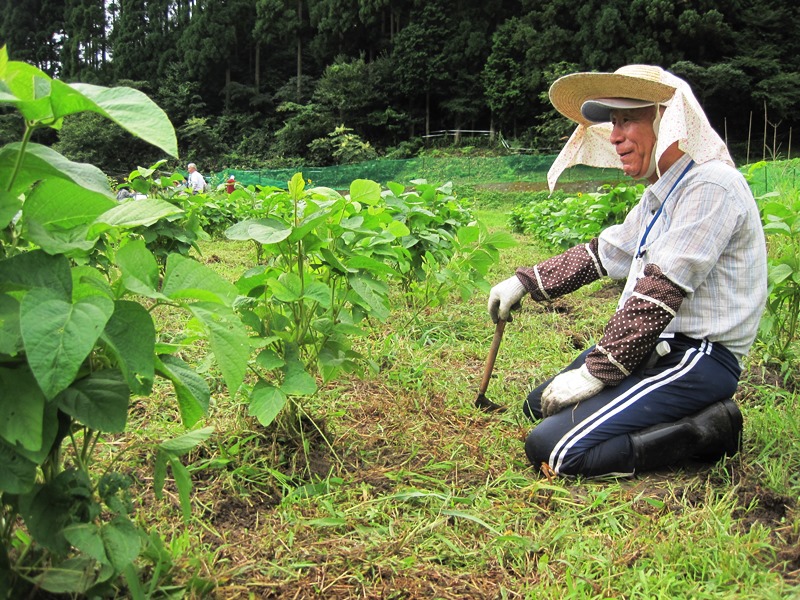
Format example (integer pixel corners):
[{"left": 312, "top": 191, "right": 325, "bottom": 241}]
[{"left": 189, "top": 302, "right": 250, "bottom": 398}]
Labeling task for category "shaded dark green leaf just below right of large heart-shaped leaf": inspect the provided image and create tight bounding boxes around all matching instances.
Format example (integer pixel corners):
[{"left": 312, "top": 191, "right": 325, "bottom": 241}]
[{"left": 56, "top": 369, "right": 131, "bottom": 433}]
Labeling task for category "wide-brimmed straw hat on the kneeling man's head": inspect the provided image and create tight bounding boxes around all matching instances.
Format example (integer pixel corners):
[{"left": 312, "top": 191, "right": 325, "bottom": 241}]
[{"left": 550, "top": 65, "right": 675, "bottom": 125}]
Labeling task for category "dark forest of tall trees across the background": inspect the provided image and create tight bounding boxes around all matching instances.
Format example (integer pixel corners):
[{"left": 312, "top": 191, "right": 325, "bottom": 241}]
[{"left": 0, "top": 0, "right": 800, "bottom": 172}]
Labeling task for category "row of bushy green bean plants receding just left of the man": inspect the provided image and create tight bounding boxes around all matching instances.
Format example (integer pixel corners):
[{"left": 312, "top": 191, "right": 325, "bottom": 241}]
[{"left": 226, "top": 173, "right": 513, "bottom": 432}]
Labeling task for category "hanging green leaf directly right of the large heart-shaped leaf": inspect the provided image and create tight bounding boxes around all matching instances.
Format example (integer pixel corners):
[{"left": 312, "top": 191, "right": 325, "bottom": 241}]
[{"left": 100, "top": 300, "right": 156, "bottom": 394}]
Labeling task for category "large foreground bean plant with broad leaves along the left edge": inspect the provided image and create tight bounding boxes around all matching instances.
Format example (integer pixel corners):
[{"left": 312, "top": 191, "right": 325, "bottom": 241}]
[{"left": 0, "top": 47, "right": 249, "bottom": 598}]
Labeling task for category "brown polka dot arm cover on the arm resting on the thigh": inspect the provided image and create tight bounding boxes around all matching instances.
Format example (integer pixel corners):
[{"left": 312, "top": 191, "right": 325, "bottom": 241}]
[{"left": 586, "top": 264, "right": 683, "bottom": 385}]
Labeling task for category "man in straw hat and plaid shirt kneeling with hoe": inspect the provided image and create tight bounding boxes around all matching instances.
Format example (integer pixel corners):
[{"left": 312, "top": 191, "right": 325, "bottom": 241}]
[{"left": 489, "top": 65, "right": 767, "bottom": 476}]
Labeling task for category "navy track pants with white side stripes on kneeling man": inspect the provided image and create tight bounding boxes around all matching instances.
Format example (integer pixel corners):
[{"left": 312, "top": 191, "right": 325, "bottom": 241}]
[{"left": 523, "top": 334, "right": 741, "bottom": 477}]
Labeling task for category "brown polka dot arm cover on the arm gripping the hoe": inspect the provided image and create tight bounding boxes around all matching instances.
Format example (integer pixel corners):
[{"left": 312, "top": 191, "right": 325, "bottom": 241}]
[{"left": 517, "top": 238, "right": 606, "bottom": 302}]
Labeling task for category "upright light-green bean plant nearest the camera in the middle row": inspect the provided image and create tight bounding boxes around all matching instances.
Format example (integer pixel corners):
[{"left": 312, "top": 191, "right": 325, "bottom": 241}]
[{"left": 226, "top": 173, "right": 409, "bottom": 432}]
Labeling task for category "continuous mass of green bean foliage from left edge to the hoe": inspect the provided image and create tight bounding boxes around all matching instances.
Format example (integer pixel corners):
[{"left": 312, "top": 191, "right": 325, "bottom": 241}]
[{"left": 0, "top": 47, "right": 513, "bottom": 598}]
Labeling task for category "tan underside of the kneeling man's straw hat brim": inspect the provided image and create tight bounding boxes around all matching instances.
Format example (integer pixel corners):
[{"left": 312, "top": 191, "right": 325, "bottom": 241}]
[{"left": 550, "top": 73, "right": 675, "bottom": 125}]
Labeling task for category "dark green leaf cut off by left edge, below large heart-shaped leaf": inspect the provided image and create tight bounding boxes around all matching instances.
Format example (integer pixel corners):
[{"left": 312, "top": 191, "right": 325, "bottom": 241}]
[{"left": 0, "top": 365, "right": 46, "bottom": 452}]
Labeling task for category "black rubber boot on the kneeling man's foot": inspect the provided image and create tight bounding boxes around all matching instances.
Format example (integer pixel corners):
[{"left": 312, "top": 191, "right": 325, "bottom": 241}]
[{"left": 630, "top": 398, "right": 742, "bottom": 473}]
